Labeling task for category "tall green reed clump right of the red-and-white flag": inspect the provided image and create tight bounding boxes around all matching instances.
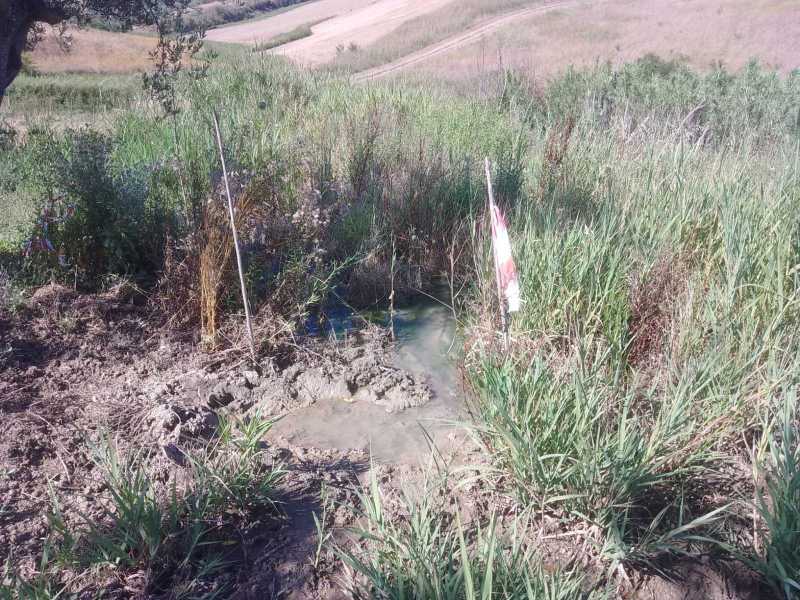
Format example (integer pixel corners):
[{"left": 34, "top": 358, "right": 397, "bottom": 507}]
[{"left": 467, "top": 59, "right": 800, "bottom": 590}]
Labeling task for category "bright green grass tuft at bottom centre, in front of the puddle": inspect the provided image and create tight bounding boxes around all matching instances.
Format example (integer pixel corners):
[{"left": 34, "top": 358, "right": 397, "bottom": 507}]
[{"left": 338, "top": 472, "right": 606, "bottom": 600}]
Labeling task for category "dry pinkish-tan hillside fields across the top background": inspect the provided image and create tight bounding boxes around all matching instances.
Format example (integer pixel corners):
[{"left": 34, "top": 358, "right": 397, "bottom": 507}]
[{"left": 25, "top": 0, "right": 800, "bottom": 82}]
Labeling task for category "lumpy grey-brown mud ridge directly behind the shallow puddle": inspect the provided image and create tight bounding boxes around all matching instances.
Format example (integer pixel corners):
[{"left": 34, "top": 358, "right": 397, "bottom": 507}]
[{"left": 141, "top": 330, "right": 432, "bottom": 442}]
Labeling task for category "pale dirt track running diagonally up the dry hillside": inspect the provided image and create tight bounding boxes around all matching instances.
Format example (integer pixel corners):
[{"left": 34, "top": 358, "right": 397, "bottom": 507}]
[{"left": 351, "top": 0, "right": 578, "bottom": 83}]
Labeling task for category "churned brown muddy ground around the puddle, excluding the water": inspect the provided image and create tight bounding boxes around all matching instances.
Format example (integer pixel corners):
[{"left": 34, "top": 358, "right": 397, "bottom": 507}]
[{"left": 0, "top": 287, "right": 769, "bottom": 600}]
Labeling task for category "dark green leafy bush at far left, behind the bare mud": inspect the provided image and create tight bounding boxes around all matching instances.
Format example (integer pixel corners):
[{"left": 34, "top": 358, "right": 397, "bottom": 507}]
[{"left": 19, "top": 130, "right": 176, "bottom": 288}]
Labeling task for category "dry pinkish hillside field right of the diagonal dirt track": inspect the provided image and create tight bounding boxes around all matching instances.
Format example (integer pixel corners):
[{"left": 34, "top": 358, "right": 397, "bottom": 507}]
[{"left": 406, "top": 0, "right": 800, "bottom": 80}]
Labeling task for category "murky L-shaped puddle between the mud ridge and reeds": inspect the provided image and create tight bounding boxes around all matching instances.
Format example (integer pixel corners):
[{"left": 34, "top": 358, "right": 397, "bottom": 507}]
[{"left": 273, "top": 300, "right": 464, "bottom": 462}]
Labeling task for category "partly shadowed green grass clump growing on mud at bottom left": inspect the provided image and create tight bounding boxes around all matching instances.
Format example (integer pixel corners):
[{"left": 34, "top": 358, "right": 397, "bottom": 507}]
[{"left": 0, "top": 415, "right": 283, "bottom": 599}]
